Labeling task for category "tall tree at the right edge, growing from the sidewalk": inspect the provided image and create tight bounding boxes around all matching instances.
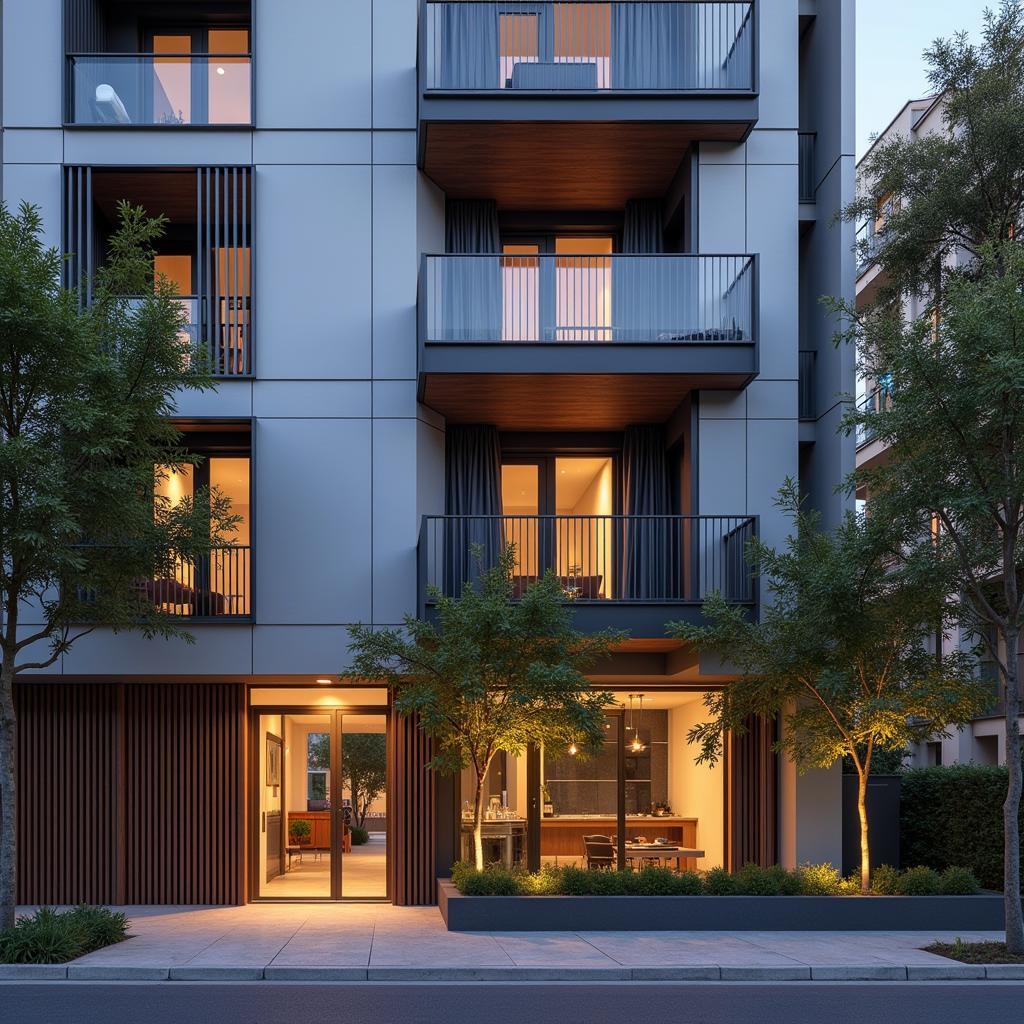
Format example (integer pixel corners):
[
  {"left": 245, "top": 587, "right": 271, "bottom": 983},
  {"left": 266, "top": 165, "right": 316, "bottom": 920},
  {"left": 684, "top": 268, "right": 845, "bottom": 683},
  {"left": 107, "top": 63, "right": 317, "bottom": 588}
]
[{"left": 834, "top": 0, "right": 1024, "bottom": 953}]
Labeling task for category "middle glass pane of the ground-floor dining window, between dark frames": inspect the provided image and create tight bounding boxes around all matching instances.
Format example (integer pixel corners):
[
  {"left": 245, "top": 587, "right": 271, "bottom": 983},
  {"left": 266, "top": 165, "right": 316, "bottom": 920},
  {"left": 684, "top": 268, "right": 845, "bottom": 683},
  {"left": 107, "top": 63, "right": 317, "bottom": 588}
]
[{"left": 541, "top": 715, "right": 621, "bottom": 868}]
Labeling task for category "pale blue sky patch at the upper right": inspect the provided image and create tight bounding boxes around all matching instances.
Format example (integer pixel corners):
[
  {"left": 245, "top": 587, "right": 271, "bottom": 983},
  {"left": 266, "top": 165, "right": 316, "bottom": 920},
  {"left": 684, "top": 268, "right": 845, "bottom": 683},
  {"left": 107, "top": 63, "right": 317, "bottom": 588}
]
[{"left": 857, "top": 0, "right": 996, "bottom": 160}]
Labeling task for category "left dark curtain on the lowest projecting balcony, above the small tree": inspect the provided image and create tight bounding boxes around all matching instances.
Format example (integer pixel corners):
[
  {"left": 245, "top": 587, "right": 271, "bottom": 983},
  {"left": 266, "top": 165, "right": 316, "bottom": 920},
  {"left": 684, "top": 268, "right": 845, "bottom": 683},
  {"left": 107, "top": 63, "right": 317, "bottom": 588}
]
[{"left": 443, "top": 425, "right": 503, "bottom": 595}]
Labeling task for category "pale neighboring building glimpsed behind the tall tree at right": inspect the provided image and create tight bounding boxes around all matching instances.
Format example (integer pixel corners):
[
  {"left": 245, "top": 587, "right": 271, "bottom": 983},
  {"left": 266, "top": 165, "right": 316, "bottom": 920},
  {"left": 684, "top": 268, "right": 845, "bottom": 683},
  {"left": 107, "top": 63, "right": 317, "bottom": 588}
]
[{"left": 857, "top": 95, "right": 1007, "bottom": 767}]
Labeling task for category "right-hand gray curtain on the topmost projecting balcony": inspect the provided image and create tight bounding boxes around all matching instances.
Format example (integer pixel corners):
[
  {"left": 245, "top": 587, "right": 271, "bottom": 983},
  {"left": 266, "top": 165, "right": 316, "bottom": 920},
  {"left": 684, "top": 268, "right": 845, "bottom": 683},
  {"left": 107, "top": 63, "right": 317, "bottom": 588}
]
[{"left": 611, "top": 3, "right": 698, "bottom": 89}]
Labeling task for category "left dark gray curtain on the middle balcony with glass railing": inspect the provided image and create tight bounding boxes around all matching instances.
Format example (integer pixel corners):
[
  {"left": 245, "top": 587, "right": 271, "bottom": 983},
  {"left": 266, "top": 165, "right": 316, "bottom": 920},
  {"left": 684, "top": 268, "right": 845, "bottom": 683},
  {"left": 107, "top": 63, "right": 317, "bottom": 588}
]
[{"left": 441, "top": 199, "right": 502, "bottom": 341}]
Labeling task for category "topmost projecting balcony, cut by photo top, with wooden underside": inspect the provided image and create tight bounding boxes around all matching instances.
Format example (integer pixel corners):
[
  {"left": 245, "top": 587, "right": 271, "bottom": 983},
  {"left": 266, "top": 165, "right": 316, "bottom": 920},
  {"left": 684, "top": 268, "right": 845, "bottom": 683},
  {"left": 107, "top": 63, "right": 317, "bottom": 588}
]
[{"left": 419, "top": 0, "right": 758, "bottom": 210}]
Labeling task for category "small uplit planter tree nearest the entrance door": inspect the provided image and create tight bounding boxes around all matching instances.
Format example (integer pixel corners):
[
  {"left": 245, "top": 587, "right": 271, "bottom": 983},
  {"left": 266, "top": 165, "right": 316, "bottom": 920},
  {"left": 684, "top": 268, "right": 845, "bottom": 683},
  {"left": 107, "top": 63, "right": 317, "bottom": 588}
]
[{"left": 349, "top": 546, "right": 622, "bottom": 869}]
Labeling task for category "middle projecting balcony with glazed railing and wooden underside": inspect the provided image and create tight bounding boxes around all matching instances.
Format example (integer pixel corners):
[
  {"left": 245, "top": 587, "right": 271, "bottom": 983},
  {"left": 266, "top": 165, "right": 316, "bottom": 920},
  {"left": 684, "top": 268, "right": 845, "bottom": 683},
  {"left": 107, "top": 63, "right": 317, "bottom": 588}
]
[{"left": 419, "top": 255, "right": 758, "bottom": 430}]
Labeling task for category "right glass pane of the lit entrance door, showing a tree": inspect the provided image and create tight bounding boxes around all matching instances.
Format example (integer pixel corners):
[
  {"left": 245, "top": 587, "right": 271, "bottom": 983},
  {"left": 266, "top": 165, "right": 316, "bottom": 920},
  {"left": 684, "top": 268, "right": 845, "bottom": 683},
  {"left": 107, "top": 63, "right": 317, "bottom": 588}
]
[{"left": 341, "top": 715, "right": 388, "bottom": 899}]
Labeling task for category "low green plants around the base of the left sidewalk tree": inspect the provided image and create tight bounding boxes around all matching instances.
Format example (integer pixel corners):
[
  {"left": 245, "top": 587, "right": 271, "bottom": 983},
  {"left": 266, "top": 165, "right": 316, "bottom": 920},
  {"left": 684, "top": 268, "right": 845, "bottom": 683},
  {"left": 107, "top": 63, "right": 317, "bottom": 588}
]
[{"left": 0, "top": 904, "right": 128, "bottom": 964}]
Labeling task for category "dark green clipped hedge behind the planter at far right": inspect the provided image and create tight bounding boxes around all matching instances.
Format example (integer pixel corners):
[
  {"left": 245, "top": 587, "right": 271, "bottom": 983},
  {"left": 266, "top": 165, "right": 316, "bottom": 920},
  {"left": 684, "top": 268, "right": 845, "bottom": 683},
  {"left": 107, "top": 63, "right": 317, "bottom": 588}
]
[{"left": 900, "top": 764, "right": 1024, "bottom": 891}]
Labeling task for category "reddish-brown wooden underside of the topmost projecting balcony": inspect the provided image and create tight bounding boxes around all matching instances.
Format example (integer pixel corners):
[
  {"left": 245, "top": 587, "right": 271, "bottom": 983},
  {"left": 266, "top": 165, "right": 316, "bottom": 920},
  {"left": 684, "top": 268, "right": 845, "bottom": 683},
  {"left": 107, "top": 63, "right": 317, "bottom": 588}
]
[{"left": 424, "top": 121, "right": 745, "bottom": 210}]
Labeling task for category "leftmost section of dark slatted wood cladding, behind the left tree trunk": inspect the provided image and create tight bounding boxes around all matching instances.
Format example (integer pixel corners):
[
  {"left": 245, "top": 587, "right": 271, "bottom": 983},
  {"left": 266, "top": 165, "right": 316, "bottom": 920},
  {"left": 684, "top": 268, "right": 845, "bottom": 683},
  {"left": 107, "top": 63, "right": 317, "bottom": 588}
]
[{"left": 14, "top": 685, "right": 121, "bottom": 903}]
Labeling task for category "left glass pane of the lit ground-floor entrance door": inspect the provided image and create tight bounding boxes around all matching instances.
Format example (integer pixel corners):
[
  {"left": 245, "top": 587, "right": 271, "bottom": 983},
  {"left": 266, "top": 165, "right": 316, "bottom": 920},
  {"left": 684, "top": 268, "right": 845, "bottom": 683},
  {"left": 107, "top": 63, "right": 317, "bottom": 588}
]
[{"left": 256, "top": 715, "right": 333, "bottom": 899}]
